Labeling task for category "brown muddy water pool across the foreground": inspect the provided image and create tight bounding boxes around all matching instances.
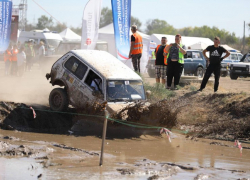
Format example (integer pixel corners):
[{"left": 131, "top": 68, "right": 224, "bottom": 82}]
[{"left": 0, "top": 130, "right": 250, "bottom": 179}]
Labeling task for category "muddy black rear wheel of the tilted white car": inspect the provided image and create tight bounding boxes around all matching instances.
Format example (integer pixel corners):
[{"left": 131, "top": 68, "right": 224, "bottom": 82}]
[{"left": 49, "top": 88, "right": 69, "bottom": 111}]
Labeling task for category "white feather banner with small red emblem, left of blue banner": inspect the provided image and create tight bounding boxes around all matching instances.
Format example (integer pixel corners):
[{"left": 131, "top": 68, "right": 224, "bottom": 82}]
[{"left": 81, "top": 0, "right": 102, "bottom": 49}]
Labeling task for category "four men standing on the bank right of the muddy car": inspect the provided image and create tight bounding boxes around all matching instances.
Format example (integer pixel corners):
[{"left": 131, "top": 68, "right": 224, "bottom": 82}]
[{"left": 129, "top": 25, "right": 230, "bottom": 92}]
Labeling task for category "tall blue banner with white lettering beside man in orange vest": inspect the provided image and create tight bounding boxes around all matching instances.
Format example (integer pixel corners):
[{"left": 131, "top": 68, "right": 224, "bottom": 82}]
[{"left": 111, "top": 0, "right": 131, "bottom": 60}]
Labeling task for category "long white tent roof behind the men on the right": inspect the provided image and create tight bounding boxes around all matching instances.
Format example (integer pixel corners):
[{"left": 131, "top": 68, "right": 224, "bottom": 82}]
[{"left": 150, "top": 34, "right": 214, "bottom": 48}]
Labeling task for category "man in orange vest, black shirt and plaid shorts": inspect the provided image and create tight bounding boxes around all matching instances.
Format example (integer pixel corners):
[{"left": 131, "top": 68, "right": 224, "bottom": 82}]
[{"left": 155, "top": 37, "right": 167, "bottom": 85}]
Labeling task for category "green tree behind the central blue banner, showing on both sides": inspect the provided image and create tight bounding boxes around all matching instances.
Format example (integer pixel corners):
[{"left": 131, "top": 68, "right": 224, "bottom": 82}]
[{"left": 99, "top": 7, "right": 142, "bottom": 30}]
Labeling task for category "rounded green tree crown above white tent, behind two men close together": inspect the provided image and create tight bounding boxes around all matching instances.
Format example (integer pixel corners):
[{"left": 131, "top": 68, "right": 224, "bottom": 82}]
[{"left": 145, "top": 19, "right": 177, "bottom": 35}]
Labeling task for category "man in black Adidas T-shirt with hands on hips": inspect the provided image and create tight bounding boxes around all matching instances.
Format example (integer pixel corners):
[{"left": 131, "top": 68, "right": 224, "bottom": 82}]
[{"left": 198, "top": 36, "right": 230, "bottom": 92}]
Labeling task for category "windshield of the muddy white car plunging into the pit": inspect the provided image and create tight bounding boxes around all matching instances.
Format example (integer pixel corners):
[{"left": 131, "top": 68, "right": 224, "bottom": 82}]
[{"left": 107, "top": 80, "right": 145, "bottom": 102}]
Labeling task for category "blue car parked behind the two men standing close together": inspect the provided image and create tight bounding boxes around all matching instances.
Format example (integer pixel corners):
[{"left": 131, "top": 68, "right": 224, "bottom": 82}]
[{"left": 146, "top": 50, "right": 206, "bottom": 77}]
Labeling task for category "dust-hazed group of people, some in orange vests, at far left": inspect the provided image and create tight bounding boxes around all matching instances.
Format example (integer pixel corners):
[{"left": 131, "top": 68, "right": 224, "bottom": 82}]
[{"left": 4, "top": 40, "right": 45, "bottom": 76}]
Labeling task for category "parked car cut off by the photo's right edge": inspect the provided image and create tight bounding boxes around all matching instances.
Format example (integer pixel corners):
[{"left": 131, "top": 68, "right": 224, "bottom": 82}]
[{"left": 230, "top": 52, "right": 250, "bottom": 80}]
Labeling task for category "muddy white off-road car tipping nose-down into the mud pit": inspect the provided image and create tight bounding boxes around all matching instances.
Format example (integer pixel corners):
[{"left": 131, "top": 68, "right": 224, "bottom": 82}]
[{"left": 46, "top": 50, "right": 146, "bottom": 111}]
